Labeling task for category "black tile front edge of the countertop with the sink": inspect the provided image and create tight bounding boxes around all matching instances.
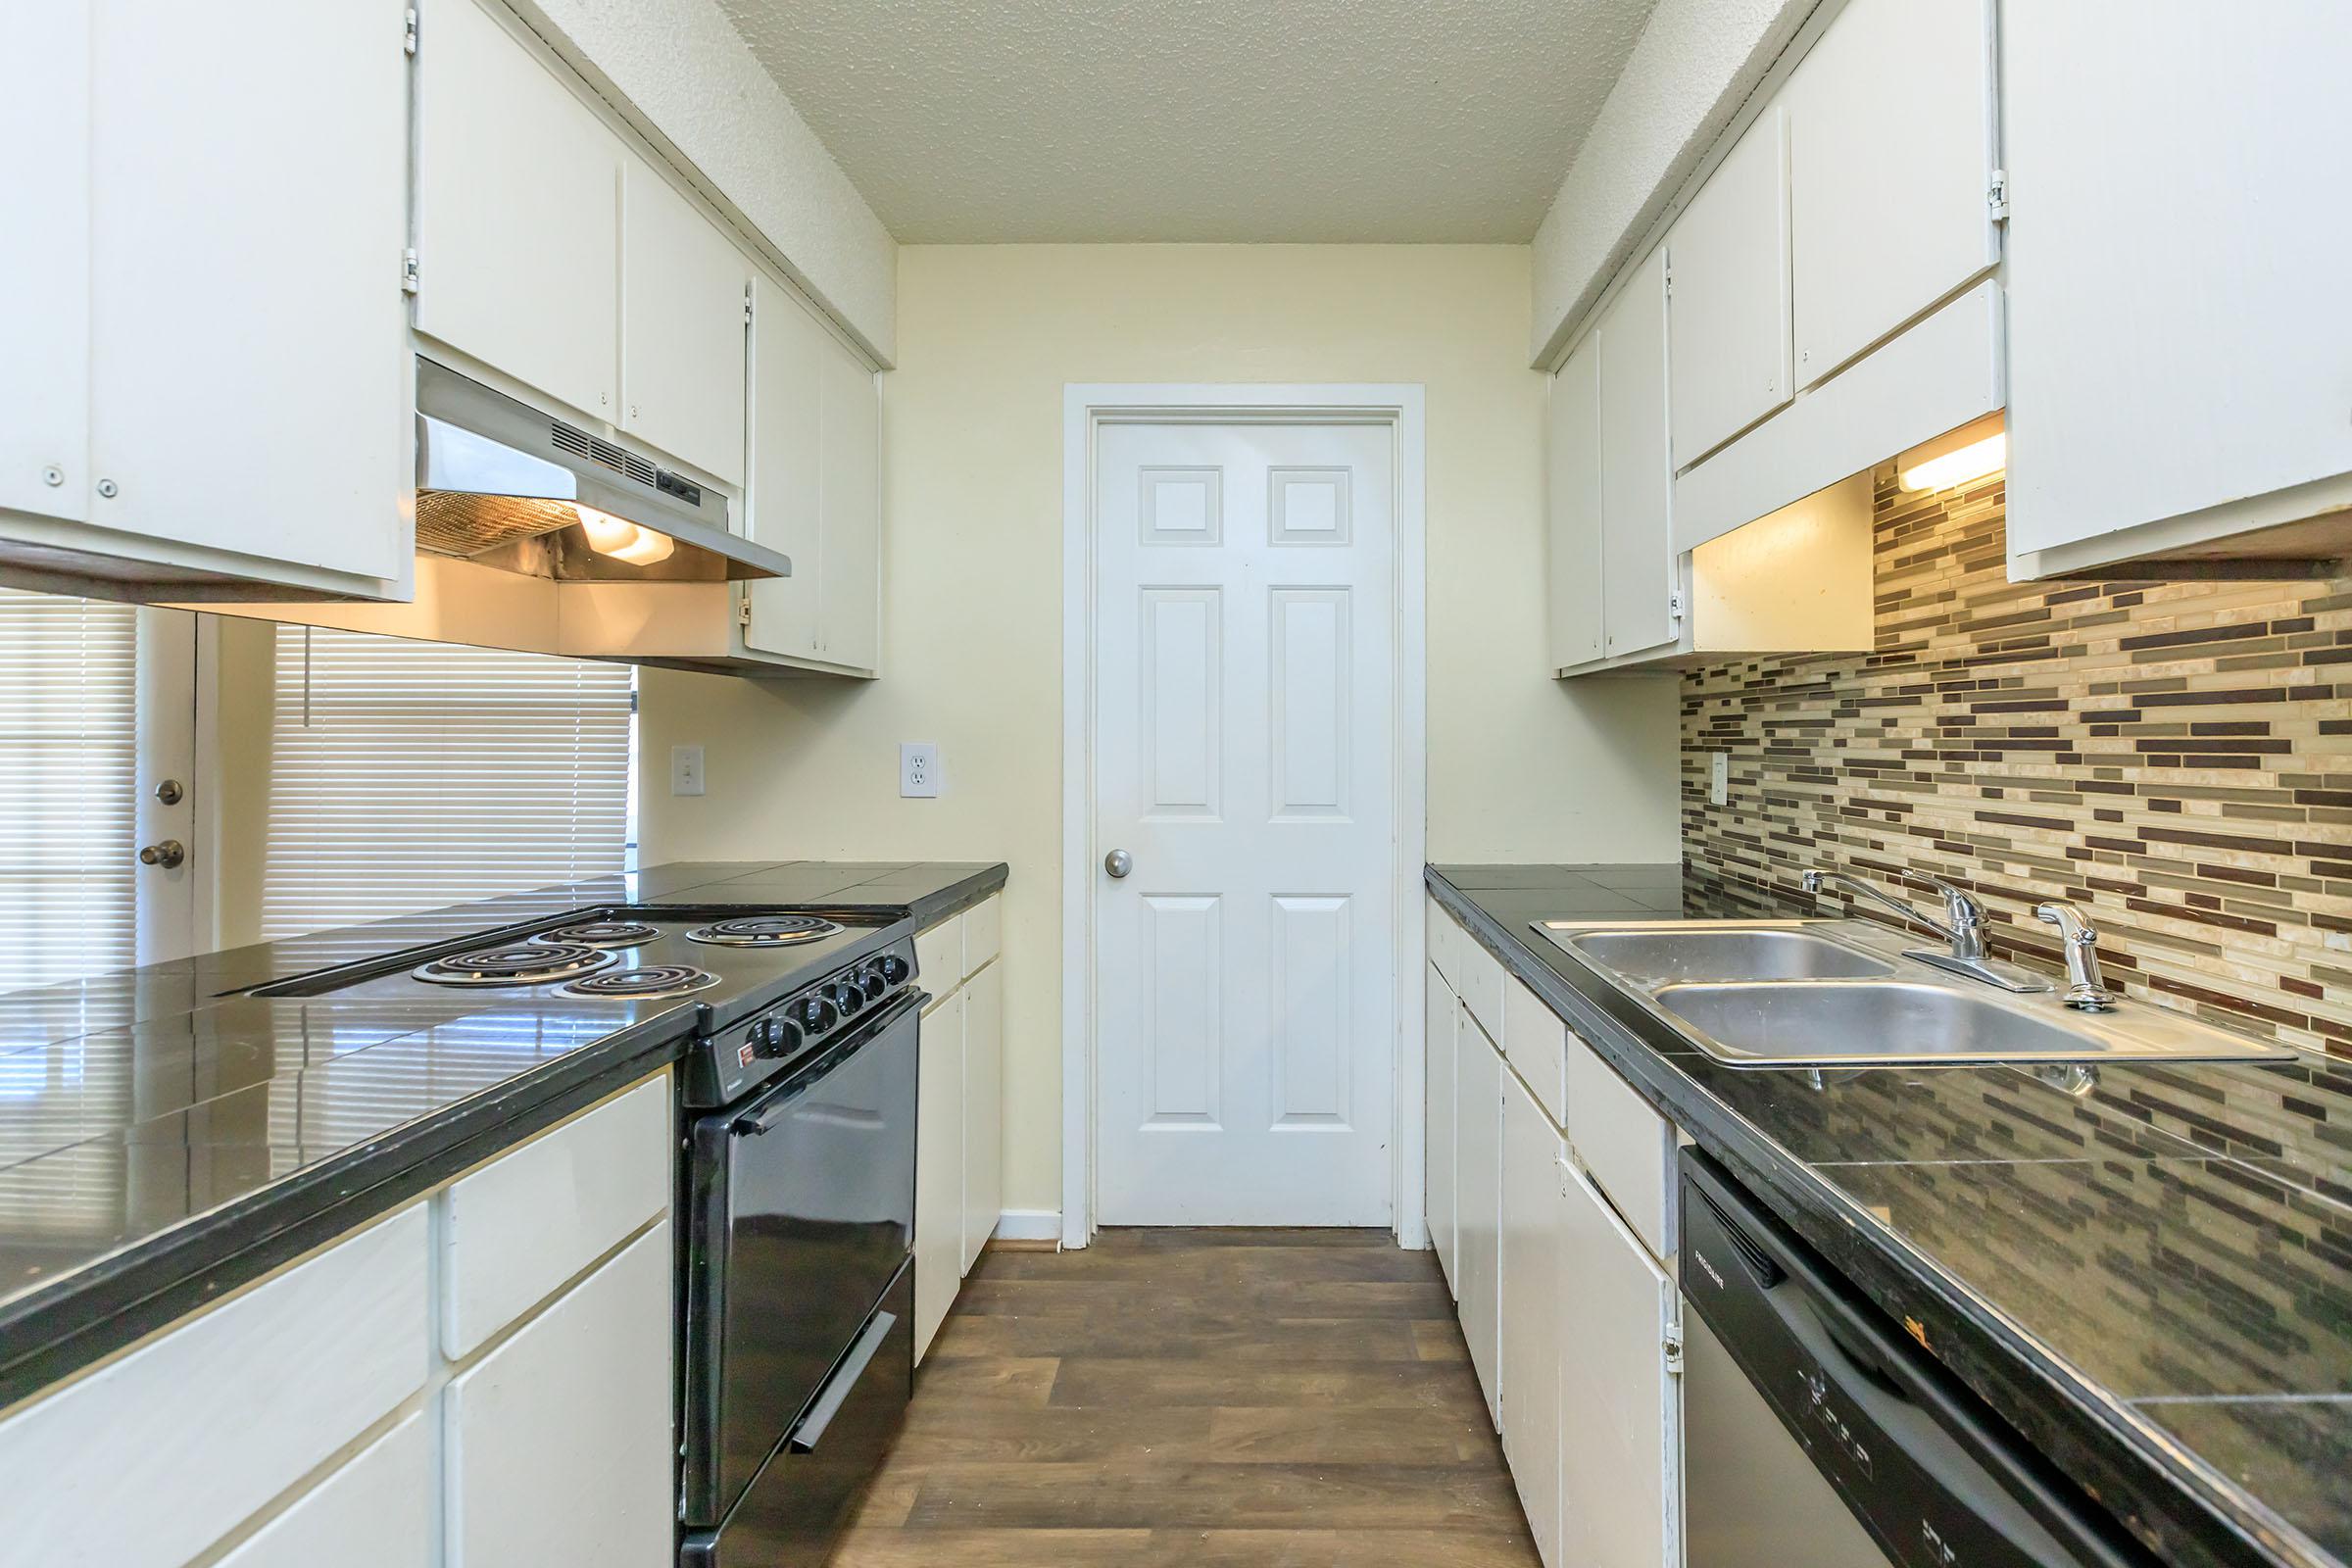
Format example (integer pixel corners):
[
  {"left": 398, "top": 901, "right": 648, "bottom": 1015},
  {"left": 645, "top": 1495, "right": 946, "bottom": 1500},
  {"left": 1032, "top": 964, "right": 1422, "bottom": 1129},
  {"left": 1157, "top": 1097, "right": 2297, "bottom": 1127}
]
[{"left": 1425, "top": 865, "right": 2335, "bottom": 1568}]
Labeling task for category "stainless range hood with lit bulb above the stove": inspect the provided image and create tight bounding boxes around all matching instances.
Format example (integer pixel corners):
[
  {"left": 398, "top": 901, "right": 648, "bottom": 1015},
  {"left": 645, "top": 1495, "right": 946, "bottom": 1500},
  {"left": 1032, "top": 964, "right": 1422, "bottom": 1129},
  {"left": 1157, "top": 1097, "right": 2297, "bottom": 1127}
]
[{"left": 416, "top": 358, "right": 793, "bottom": 583}]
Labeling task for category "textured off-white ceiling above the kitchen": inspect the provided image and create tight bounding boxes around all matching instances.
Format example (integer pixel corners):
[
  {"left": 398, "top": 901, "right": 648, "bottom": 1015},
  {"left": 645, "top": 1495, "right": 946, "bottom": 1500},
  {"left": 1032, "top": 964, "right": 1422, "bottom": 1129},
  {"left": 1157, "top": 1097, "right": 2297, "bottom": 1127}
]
[{"left": 722, "top": 0, "right": 1653, "bottom": 242}]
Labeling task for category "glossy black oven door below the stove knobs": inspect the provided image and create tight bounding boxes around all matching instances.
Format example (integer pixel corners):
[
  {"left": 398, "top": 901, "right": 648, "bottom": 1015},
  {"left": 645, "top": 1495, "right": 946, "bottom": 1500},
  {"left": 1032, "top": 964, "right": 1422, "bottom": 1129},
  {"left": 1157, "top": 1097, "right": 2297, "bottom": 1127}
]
[{"left": 680, "top": 992, "right": 924, "bottom": 1531}]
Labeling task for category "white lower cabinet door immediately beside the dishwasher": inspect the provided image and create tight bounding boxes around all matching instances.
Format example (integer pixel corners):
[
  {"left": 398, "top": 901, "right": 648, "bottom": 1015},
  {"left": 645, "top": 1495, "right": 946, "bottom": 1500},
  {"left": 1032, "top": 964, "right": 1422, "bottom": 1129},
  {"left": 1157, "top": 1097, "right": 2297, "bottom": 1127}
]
[{"left": 1559, "top": 1171, "right": 1682, "bottom": 1568}]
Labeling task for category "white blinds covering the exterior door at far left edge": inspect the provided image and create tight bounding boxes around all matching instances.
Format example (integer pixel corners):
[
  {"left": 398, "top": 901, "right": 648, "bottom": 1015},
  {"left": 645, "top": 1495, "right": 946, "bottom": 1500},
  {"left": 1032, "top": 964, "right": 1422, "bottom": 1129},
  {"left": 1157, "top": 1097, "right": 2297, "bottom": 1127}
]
[{"left": 0, "top": 588, "right": 139, "bottom": 992}]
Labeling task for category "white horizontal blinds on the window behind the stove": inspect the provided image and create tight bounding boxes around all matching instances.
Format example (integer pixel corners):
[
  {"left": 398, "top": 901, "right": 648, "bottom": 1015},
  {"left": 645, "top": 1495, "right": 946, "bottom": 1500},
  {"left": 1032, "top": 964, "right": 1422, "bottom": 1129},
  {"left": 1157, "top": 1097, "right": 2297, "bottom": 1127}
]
[{"left": 261, "top": 625, "right": 630, "bottom": 938}]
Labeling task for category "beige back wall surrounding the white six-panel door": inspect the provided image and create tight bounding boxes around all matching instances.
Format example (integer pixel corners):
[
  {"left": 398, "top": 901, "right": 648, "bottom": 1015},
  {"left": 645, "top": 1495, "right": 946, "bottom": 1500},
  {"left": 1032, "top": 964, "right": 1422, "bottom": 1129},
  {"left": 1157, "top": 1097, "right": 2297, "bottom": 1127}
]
[{"left": 640, "top": 244, "right": 1680, "bottom": 1208}]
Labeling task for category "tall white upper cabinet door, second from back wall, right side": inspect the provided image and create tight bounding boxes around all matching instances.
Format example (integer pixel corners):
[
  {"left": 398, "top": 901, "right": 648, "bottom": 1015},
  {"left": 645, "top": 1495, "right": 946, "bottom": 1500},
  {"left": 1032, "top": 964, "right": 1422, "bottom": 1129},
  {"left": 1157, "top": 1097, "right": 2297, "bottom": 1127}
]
[{"left": 1599, "top": 247, "right": 1675, "bottom": 659}]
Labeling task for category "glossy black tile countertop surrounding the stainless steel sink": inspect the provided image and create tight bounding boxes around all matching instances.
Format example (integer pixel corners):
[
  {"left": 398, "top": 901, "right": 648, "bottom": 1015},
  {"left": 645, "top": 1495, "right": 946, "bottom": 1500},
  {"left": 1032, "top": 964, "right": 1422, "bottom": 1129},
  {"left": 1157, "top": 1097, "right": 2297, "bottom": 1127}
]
[{"left": 1428, "top": 865, "right": 2352, "bottom": 1568}]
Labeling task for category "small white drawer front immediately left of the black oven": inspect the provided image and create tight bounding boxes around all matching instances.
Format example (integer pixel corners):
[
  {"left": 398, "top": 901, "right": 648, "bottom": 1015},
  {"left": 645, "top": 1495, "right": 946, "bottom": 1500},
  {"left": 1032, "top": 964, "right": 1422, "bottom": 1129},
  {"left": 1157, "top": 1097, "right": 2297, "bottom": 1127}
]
[{"left": 440, "top": 1074, "right": 677, "bottom": 1361}]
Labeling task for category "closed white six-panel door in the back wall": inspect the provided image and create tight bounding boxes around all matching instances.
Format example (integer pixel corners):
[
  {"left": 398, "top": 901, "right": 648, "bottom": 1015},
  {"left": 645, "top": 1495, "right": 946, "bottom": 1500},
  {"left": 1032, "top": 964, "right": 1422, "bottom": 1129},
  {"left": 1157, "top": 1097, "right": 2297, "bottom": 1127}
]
[{"left": 1092, "top": 420, "right": 1397, "bottom": 1225}]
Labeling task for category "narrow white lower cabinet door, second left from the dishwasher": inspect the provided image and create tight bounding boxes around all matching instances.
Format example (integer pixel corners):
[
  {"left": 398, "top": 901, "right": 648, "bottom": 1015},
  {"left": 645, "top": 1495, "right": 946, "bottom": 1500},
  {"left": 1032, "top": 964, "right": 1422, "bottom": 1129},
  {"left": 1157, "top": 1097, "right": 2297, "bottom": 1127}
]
[{"left": 1500, "top": 1072, "right": 1564, "bottom": 1568}]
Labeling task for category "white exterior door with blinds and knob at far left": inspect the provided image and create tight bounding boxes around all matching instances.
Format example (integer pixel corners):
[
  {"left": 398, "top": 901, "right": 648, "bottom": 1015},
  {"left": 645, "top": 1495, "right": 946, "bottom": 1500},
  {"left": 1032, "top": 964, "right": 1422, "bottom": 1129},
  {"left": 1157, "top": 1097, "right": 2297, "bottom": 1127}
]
[{"left": 0, "top": 588, "right": 207, "bottom": 992}]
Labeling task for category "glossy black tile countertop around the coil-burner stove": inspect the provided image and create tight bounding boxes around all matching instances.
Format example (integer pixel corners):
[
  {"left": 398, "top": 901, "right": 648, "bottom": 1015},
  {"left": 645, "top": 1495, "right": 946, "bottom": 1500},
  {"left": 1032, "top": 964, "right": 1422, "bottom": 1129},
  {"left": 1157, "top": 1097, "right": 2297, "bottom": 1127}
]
[{"left": 0, "top": 860, "right": 1004, "bottom": 1405}]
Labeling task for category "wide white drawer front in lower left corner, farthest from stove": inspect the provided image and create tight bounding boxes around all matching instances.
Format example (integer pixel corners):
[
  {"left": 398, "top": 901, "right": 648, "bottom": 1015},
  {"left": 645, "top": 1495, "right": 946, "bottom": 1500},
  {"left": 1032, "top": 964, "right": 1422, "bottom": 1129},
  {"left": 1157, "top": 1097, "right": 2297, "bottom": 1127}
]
[{"left": 0, "top": 1203, "right": 430, "bottom": 1568}]
